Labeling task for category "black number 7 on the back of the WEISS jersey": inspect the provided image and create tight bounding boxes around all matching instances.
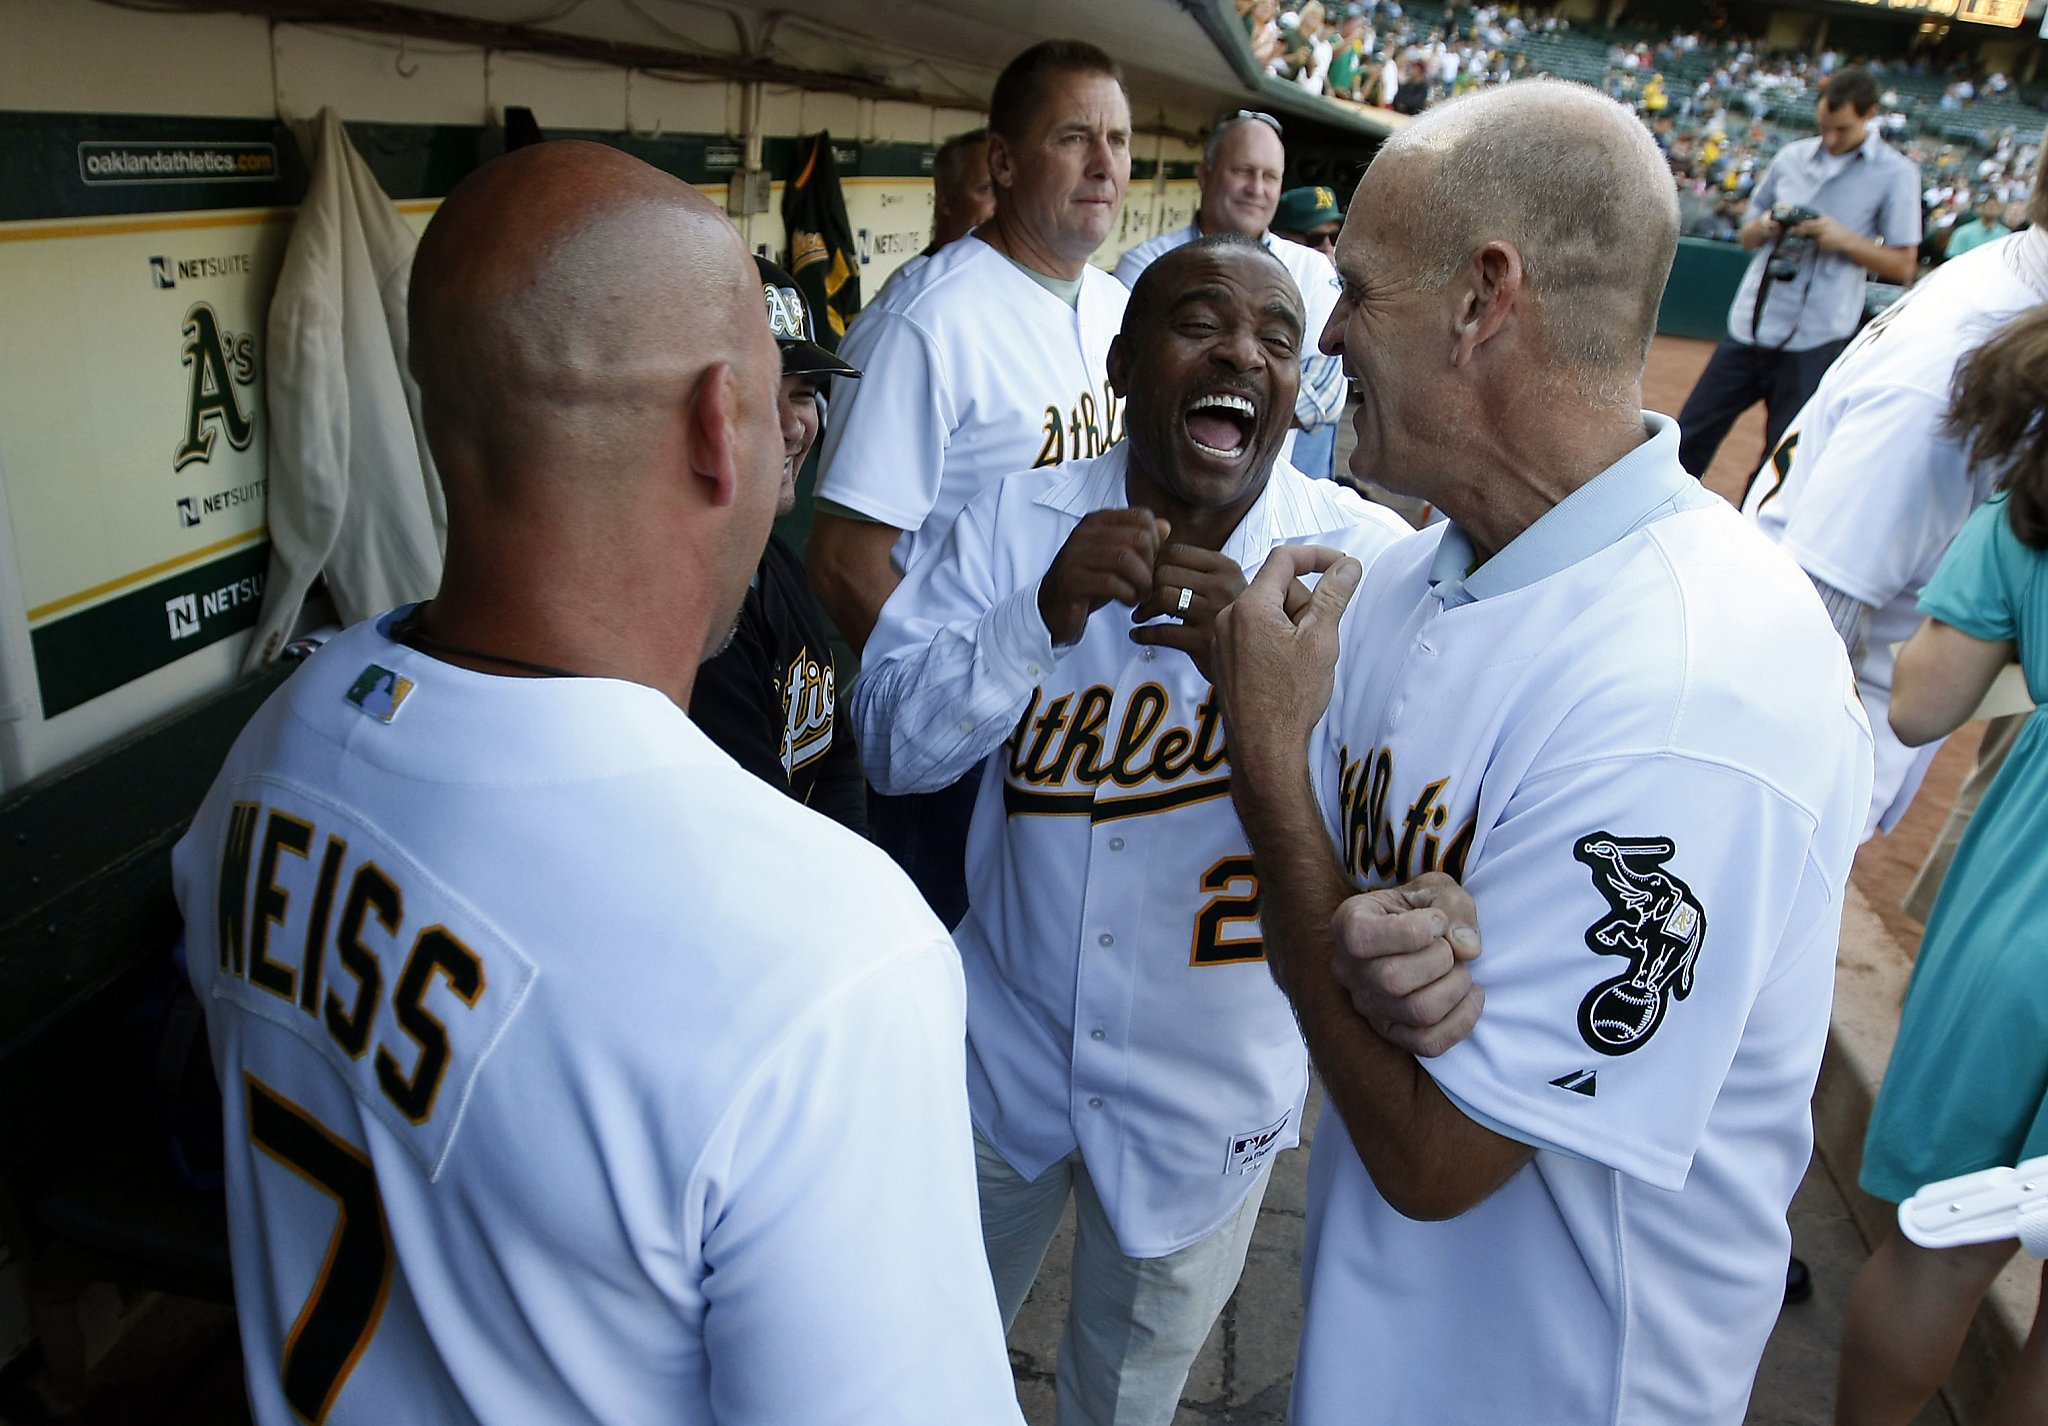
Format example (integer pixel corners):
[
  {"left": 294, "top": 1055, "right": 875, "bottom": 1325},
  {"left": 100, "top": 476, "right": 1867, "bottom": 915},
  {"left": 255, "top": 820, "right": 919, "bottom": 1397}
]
[{"left": 242, "top": 1072, "right": 391, "bottom": 1426}]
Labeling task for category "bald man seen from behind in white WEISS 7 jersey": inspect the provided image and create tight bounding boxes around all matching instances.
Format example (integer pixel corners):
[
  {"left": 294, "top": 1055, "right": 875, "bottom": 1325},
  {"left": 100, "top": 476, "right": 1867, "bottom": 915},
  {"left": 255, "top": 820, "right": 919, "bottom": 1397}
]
[{"left": 174, "top": 143, "right": 1020, "bottom": 1426}]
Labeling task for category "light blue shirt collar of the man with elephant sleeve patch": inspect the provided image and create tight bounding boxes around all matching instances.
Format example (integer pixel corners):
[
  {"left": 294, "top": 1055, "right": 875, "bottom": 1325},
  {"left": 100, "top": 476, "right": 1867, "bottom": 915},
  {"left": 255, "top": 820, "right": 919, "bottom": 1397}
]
[{"left": 1430, "top": 412, "right": 1720, "bottom": 609}]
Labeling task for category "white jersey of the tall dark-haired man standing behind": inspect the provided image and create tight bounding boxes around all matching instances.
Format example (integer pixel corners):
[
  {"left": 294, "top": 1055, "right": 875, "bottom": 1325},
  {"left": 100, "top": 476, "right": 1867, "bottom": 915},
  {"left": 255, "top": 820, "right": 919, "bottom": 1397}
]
[{"left": 817, "top": 234, "right": 1130, "bottom": 570}]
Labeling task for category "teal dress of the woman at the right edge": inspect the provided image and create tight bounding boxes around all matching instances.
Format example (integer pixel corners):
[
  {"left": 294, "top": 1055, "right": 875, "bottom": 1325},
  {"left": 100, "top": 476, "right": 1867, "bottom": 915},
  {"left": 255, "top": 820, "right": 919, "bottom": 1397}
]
[{"left": 1862, "top": 496, "right": 2048, "bottom": 1203}]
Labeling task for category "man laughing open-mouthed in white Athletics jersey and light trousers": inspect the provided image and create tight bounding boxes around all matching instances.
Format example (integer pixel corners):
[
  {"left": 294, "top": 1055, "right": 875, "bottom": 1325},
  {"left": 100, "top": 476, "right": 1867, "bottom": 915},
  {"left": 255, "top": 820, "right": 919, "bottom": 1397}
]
[{"left": 854, "top": 236, "right": 1433, "bottom": 1426}]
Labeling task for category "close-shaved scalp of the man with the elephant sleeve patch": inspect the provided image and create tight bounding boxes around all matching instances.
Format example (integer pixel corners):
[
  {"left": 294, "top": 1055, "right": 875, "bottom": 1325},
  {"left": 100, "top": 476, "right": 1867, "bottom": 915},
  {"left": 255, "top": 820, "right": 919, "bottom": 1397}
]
[{"left": 1356, "top": 80, "right": 1677, "bottom": 381}]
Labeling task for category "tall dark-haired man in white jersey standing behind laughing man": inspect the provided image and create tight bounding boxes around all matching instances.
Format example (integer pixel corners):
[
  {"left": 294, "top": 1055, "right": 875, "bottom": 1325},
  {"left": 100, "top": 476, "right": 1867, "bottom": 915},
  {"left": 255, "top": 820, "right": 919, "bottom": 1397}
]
[{"left": 805, "top": 39, "right": 1130, "bottom": 926}]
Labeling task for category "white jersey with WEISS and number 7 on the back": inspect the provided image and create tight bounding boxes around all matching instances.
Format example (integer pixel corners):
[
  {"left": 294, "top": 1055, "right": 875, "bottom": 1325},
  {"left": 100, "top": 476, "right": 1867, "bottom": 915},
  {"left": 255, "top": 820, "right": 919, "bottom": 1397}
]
[{"left": 174, "top": 615, "right": 1020, "bottom": 1426}]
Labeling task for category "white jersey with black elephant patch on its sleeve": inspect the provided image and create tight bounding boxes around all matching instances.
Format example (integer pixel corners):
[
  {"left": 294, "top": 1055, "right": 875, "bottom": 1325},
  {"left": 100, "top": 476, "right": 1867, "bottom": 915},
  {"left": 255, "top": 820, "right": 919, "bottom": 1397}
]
[{"left": 1290, "top": 416, "right": 1870, "bottom": 1426}]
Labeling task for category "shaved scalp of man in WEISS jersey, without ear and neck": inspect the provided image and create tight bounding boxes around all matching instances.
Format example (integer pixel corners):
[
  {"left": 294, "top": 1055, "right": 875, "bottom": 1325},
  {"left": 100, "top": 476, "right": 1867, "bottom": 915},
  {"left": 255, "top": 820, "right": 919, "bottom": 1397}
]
[{"left": 408, "top": 143, "right": 776, "bottom": 500}]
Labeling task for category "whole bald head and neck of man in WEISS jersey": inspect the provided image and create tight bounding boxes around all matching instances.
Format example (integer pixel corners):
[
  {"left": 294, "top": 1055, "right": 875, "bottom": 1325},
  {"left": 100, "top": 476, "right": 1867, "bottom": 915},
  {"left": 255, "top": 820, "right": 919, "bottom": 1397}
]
[{"left": 410, "top": 143, "right": 782, "bottom": 688}]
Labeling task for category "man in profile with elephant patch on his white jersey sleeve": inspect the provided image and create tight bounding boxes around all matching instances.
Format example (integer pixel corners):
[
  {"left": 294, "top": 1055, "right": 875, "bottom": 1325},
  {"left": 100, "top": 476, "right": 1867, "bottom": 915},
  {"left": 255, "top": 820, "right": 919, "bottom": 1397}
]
[{"left": 1217, "top": 80, "right": 1870, "bottom": 1426}]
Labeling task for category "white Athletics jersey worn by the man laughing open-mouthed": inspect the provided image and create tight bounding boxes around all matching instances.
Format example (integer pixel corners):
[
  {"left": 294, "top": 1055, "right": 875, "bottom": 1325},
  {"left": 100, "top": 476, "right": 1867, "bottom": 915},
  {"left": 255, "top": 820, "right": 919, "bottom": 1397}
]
[{"left": 854, "top": 445, "right": 1407, "bottom": 1258}]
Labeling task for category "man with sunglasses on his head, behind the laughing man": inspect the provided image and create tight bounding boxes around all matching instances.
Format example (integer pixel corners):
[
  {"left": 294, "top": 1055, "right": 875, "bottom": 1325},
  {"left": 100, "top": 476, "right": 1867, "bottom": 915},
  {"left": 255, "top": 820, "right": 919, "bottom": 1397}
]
[{"left": 1116, "top": 109, "right": 1346, "bottom": 479}]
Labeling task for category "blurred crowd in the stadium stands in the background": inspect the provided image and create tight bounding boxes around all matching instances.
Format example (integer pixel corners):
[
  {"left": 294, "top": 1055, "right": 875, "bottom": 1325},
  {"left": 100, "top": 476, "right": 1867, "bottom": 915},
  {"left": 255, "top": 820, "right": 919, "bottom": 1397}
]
[{"left": 1237, "top": 0, "right": 2048, "bottom": 260}]
